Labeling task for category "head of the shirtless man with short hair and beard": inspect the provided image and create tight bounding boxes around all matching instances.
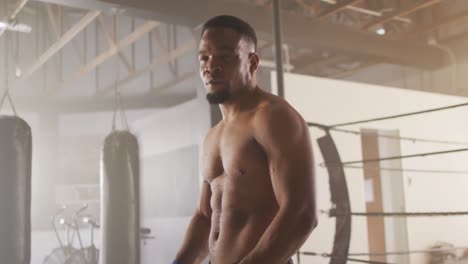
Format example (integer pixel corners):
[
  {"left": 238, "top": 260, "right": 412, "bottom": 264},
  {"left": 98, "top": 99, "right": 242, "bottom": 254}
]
[{"left": 198, "top": 15, "right": 259, "bottom": 104}]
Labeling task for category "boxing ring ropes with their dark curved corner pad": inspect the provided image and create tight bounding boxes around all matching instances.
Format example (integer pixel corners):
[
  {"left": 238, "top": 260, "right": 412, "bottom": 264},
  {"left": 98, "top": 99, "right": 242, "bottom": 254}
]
[{"left": 297, "top": 103, "right": 468, "bottom": 264}]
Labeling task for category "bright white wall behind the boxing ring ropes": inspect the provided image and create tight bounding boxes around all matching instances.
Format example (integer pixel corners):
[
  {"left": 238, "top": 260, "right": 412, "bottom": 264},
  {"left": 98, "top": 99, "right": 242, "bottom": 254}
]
[{"left": 272, "top": 73, "right": 468, "bottom": 264}]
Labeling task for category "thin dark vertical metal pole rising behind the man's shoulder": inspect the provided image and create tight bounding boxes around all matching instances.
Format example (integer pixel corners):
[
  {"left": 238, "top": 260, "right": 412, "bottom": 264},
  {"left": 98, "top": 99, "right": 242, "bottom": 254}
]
[{"left": 273, "top": 0, "right": 284, "bottom": 97}]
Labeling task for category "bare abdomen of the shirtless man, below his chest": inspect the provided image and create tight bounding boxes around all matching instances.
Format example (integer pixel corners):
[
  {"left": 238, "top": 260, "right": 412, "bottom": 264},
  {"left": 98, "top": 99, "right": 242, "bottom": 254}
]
[{"left": 209, "top": 174, "right": 278, "bottom": 264}]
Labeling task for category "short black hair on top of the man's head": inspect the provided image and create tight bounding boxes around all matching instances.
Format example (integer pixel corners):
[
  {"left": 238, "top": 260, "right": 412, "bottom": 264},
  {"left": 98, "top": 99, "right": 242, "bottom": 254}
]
[{"left": 201, "top": 15, "right": 257, "bottom": 50}]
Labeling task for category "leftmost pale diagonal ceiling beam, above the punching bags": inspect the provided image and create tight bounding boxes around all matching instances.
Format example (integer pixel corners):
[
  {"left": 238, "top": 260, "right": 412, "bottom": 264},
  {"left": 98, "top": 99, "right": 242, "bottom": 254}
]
[{"left": 21, "top": 11, "right": 101, "bottom": 79}]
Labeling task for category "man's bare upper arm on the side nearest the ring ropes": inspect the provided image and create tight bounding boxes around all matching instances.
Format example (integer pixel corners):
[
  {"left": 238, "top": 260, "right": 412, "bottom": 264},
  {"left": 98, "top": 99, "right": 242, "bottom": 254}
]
[{"left": 260, "top": 108, "right": 314, "bottom": 204}]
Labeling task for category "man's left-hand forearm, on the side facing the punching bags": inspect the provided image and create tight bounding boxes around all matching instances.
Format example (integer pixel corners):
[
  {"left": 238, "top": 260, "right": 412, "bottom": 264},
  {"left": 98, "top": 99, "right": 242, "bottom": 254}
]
[{"left": 176, "top": 212, "right": 211, "bottom": 264}]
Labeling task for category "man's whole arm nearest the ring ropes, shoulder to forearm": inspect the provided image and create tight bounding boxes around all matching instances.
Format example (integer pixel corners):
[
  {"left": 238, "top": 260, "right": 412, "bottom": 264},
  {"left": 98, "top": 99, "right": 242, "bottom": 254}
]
[{"left": 240, "top": 103, "right": 317, "bottom": 264}]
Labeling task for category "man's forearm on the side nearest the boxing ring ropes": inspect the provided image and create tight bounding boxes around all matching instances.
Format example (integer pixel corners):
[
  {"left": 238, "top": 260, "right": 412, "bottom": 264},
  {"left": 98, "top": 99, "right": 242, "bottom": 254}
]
[{"left": 239, "top": 208, "right": 317, "bottom": 264}]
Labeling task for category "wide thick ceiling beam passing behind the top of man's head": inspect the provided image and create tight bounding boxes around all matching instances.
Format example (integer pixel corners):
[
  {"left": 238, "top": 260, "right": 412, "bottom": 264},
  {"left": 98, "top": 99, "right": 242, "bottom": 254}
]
[{"left": 94, "top": 0, "right": 448, "bottom": 69}]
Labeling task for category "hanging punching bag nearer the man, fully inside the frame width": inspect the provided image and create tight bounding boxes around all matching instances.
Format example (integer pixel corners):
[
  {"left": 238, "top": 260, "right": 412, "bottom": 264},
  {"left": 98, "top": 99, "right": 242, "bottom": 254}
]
[{"left": 99, "top": 131, "right": 140, "bottom": 264}]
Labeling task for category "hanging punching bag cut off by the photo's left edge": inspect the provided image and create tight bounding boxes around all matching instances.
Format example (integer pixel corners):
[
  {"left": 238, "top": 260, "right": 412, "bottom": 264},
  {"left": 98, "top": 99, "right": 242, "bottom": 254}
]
[{"left": 0, "top": 115, "right": 32, "bottom": 264}]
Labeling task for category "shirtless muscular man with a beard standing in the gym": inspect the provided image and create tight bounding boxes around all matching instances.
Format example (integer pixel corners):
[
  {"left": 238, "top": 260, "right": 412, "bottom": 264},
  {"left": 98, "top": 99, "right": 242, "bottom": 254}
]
[{"left": 173, "top": 16, "right": 317, "bottom": 264}]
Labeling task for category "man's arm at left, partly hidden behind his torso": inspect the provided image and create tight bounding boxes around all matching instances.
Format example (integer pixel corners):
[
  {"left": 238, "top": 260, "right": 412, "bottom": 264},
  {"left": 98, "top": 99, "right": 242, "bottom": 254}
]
[{"left": 176, "top": 181, "right": 211, "bottom": 264}]
